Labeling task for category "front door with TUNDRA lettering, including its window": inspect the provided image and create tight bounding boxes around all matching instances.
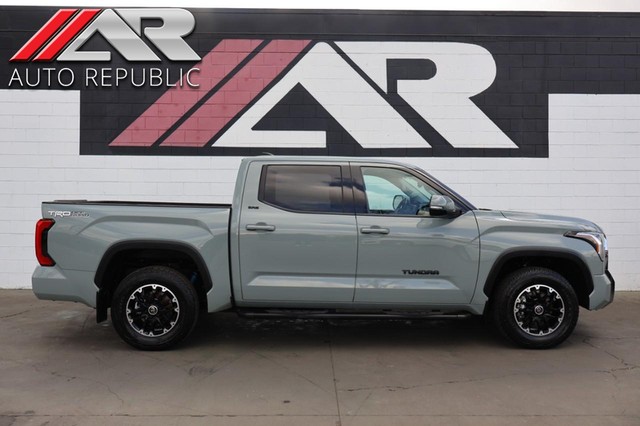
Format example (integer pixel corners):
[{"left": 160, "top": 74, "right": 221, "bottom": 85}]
[{"left": 352, "top": 165, "right": 480, "bottom": 306}]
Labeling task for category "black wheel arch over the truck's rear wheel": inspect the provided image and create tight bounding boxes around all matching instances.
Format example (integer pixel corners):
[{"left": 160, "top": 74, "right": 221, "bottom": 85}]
[{"left": 94, "top": 240, "right": 213, "bottom": 322}]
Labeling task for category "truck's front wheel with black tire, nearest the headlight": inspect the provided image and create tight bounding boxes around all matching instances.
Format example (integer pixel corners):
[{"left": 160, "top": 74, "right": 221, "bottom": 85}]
[{"left": 490, "top": 267, "right": 580, "bottom": 349}]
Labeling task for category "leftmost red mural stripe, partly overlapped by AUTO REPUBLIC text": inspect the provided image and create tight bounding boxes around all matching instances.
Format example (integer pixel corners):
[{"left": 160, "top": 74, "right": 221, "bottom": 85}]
[{"left": 109, "top": 40, "right": 262, "bottom": 146}]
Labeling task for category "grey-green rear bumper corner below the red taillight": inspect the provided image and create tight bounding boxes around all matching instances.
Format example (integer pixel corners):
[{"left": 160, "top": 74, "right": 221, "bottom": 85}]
[{"left": 31, "top": 266, "right": 98, "bottom": 308}]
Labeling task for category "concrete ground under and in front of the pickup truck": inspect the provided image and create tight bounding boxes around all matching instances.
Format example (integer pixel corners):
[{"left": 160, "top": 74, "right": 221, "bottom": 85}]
[{"left": 0, "top": 290, "right": 640, "bottom": 426}]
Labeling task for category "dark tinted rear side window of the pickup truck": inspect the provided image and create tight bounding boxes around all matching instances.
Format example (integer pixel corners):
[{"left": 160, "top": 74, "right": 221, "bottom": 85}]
[{"left": 258, "top": 165, "right": 344, "bottom": 213}]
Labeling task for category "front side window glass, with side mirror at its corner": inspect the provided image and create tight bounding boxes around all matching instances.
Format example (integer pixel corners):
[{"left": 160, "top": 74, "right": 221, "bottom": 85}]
[{"left": 361, "top": 167, "right": 439, "bottom": 215}]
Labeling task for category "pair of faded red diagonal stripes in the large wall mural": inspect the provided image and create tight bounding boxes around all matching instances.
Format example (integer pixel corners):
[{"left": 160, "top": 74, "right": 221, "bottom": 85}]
[{"left": 109, "top": 39, "right": 310, "bottom": 147}]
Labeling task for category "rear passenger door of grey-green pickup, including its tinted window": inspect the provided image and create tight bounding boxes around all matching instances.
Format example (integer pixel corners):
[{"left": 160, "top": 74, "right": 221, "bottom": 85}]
[{"left": 238, "top": 162, "right": 357, "bottom": 307}]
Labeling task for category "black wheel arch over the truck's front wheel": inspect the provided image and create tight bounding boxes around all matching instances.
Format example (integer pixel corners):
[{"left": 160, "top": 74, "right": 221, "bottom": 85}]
[{"left": 483, "top": 249, "right": 593, "bottom": 308}]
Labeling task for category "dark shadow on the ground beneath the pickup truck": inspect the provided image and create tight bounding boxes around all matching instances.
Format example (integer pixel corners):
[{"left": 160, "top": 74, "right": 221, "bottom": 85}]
[{"left": 51, "top": 309, "right": 591, "bottom": 355}]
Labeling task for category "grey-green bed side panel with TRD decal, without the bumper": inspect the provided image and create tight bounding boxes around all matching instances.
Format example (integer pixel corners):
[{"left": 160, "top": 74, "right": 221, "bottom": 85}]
[{"left": 42, "top": 203, "right": 231, "bottom": 311}]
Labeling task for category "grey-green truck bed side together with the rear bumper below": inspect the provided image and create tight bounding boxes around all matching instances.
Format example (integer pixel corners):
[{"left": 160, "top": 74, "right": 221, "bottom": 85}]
[{"left": 32, "top": 200, "right": 231, "bottom": 310}]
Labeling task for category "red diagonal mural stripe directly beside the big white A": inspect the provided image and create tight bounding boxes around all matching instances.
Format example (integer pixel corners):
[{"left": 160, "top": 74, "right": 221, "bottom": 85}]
[{"left": 161, "top": 40, "right": 310, "bottom": 147}]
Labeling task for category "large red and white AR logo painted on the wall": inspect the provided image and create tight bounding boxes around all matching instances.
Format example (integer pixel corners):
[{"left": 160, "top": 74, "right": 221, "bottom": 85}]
[{"left": 110, "top": 39, "right": 518, "bottom": 150}]
